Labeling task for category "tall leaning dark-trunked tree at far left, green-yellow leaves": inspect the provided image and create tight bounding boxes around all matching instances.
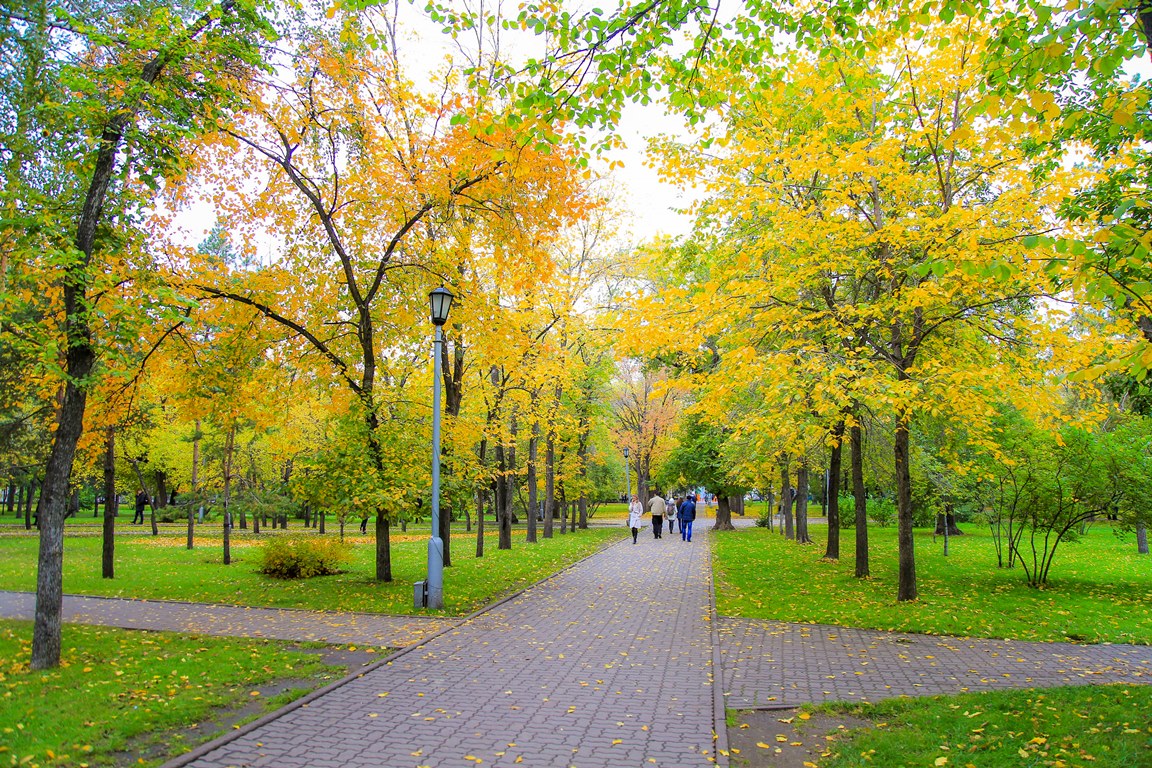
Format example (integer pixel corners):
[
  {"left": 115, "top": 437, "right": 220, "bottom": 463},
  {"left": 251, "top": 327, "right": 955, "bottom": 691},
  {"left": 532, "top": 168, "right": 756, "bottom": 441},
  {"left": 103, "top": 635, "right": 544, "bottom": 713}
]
[{"left": 0, "top": 0, "right": 264, "bottom": 669}]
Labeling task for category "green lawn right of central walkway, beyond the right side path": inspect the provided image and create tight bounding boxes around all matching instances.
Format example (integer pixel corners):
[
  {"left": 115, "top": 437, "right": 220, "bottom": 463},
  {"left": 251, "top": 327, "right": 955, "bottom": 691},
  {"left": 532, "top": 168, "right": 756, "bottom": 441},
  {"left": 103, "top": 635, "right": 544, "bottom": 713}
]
[{"left": 713, "top": 524, "right": 1152, "bottom": 644}]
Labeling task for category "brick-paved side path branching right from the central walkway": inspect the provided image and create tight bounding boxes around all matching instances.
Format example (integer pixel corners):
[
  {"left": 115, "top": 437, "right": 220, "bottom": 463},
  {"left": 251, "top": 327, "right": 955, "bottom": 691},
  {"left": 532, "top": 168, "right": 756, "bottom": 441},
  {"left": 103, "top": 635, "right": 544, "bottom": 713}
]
[{"left": 720, "top": 617, "right": 1152, "bottom": 708}]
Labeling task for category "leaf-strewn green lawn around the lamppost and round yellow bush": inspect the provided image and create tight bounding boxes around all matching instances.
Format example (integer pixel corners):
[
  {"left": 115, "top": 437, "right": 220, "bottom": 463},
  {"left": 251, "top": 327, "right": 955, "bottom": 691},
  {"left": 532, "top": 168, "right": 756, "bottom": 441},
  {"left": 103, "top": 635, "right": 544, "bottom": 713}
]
[{"left": 0, "top": 527, "right": 626, "bottom": 615}]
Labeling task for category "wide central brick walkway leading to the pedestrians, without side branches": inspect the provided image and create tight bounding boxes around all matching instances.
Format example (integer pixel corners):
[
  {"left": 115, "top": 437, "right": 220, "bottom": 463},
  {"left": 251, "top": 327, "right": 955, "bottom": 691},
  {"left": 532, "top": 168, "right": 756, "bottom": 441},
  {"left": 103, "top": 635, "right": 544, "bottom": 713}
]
[{"left": 168, "top": 531, "right": 722, "bottom": 768}]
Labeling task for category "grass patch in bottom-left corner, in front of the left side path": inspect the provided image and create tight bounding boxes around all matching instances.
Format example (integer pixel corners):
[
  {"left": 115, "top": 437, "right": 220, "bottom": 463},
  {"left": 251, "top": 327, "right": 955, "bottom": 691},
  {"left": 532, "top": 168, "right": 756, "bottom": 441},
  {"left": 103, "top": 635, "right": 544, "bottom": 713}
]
[{"left": 0, "top": 621, "right": 342, "bottom": 768}]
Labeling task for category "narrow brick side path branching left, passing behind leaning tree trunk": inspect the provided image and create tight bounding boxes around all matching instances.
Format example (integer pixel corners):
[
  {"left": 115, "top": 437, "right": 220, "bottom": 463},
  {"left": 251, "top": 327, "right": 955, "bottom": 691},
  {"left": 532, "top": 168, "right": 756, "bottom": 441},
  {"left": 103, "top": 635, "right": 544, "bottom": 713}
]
[{"left": 0, "top": 592, "right": 458, "bottom": 648}]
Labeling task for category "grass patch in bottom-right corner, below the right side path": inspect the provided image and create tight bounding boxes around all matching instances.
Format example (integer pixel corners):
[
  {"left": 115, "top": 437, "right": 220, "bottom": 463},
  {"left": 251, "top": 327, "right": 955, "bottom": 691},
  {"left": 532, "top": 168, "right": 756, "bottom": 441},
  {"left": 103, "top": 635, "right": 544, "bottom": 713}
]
[{"left": 818, "top": 685, "right": 1152, "bottom": 768}]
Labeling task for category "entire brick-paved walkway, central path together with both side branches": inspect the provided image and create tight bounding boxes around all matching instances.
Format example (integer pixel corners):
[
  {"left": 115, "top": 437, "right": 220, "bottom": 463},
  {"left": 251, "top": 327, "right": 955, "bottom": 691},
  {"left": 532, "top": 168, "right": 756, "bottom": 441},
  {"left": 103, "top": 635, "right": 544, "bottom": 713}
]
[{"left": 0, "top": 520, "right": 1152, "bottom": 768}]
